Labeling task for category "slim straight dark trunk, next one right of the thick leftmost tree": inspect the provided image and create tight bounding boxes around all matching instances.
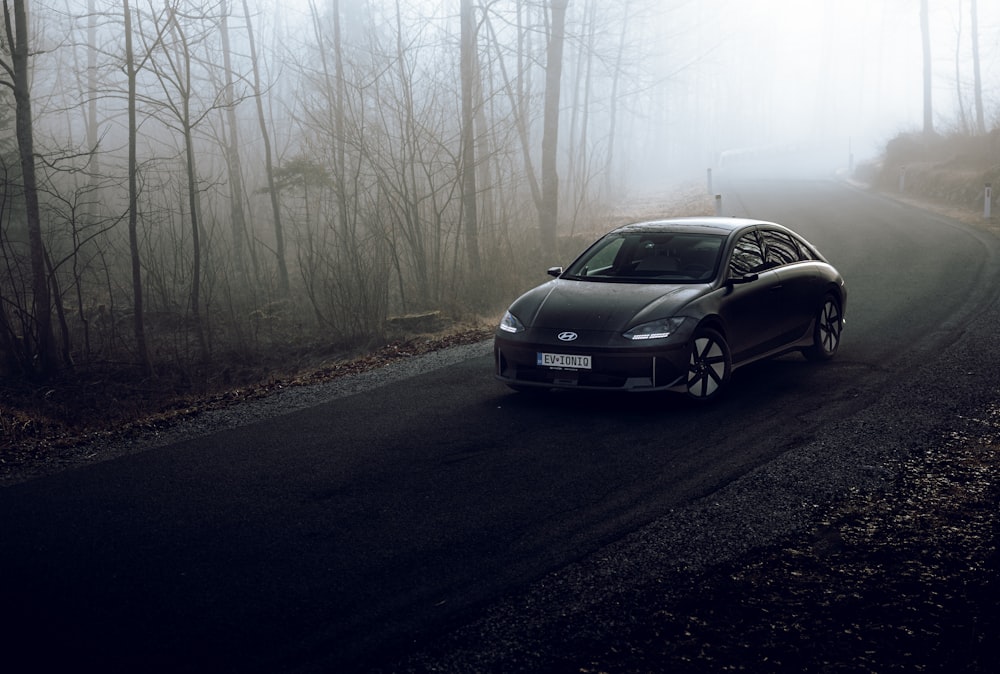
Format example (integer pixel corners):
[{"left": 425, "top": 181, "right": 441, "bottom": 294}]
[{"left": 122, "top": 0, "right": 153, "bottom": 377}]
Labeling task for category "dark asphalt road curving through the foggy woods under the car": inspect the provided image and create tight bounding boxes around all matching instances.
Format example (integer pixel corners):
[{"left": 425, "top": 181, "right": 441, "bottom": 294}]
[{"left": 0, "top": 176, "right": 1000, "bottom": 672}]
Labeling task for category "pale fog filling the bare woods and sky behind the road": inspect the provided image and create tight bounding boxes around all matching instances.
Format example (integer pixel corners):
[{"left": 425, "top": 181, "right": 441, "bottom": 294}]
[{"left": 0, "top": 0, "right": 1000, "bottom": 378}]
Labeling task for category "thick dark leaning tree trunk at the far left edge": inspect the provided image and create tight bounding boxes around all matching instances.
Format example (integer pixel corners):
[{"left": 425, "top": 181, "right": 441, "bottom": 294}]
[{"left": 3, "top": 0, "right": 56, "bottom": 378}]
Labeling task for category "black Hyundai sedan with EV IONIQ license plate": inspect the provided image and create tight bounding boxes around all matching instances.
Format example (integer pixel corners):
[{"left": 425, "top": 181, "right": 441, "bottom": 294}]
[{"left": 493, "top": 217, "right": 847, "bottom": 400}]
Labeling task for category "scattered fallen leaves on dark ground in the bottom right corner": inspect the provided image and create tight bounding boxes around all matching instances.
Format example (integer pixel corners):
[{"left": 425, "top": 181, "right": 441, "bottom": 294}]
[{"left": 572, "top": 410, "right": 1000, "bottom": 674}]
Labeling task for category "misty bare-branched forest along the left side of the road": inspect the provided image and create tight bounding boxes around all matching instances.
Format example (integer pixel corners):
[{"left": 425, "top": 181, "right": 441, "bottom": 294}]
[{"left": 0, "top": 0, "right": 988, "bottom": 400}]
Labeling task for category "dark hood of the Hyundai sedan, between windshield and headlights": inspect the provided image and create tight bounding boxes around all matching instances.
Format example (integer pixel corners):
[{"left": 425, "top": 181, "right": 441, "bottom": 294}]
[{"left": 510, "top": 279, "right": 711, "bottom": 331}]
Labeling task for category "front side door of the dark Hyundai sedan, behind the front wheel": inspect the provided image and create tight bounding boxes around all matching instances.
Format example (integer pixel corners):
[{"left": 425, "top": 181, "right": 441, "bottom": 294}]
[{"left": 723, "top": 231, "right": 785, "bottom": 362}]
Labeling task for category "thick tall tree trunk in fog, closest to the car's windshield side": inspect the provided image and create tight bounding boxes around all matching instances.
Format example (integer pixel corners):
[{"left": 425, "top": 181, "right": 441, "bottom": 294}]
[{"left": 538, "top": 0, "right": 568, "bottom": 255}]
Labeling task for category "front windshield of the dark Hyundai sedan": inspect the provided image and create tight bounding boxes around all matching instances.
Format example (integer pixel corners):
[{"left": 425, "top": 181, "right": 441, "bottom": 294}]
[{"left": 563, "top": 232, "right": 724, "bottom": 283}]
